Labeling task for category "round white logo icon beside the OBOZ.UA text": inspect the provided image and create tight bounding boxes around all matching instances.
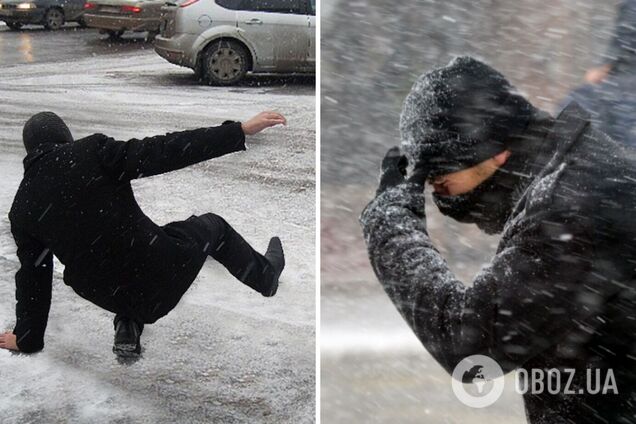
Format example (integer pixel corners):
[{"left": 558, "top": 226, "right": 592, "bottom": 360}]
[{"left": 452, "top": 355, "right": 504, "bottom": 408}]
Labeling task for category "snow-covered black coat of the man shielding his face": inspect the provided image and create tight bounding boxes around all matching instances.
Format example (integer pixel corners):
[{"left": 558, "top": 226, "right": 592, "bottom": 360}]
[{"left": 361, "top": 104, "right": 636, "bottom": 423}]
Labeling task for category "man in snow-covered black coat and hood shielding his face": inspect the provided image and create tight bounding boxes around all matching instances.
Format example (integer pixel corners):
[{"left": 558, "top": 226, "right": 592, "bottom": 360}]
[{"left": 361, "top": 57, "right": 636, "bottom": 423}]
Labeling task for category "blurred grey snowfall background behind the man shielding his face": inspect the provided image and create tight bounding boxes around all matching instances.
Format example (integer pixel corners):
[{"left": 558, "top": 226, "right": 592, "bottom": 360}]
[{"left": 321, "top": 0, "right": 618, "bottom": 424}]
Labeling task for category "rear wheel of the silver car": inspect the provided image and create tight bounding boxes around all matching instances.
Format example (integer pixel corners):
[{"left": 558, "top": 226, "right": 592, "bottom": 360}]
[{"left": 201, "top": 40, "right": 250, "bottom": 86}]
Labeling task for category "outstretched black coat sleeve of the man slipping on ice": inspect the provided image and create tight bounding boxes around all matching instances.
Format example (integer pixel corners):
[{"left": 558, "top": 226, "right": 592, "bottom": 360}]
[{"left": 98, "top": 121, "right": 245, "bottom": 180}]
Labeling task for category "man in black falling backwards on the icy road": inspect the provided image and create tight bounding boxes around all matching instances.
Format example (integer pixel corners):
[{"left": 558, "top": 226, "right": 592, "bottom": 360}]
[{"left": 0, "top": 112, "right": 286, "bottom": 356}]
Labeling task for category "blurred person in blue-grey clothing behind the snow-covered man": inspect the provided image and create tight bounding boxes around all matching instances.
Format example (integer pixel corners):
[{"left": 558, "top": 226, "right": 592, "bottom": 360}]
[{"left": 561, "top": 0, "right": 636, "bottom": 146}]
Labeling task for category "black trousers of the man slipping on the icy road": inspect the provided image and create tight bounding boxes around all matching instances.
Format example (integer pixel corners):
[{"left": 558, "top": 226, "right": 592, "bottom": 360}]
[{"left": 113, "top": 213, "right": 275, "bottom": 330}]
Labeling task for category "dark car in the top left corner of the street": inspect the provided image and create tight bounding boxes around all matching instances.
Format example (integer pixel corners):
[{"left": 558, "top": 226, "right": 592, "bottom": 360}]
[{"left": 0, "top": 0, "right": 85, "bottom": 30}]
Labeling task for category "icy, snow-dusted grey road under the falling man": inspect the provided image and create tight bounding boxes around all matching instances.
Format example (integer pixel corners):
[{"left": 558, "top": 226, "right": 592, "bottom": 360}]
[{"left": 0, "top": 26, "right": 315, "bottom": 423}]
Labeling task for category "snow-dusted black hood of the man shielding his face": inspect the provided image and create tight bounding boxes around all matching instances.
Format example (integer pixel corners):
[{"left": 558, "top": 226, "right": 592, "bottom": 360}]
[{"left": 400, "top": 57, "right": 539, "bottom": 176}]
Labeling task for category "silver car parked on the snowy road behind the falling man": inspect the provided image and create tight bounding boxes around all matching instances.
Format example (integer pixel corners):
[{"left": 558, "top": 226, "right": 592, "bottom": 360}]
[{"left": 155, "top": 0, "right": 316, "bottom": 85}]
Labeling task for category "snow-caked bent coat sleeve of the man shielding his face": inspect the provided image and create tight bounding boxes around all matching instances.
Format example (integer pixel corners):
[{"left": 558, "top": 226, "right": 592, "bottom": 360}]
[{"left": 361, "top": 176, "right": 611, "bottom": 373}]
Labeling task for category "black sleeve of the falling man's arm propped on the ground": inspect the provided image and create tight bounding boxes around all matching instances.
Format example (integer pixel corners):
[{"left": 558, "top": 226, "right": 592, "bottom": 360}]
[{"left": 11, "top": 227, "right": 53, "bottom": 353}]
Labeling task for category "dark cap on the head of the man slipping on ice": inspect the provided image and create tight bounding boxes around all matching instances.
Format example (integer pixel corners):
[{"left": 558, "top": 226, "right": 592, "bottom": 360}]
[{"left": 22, "top": 112, "right": 73, "bottom": 153}]
